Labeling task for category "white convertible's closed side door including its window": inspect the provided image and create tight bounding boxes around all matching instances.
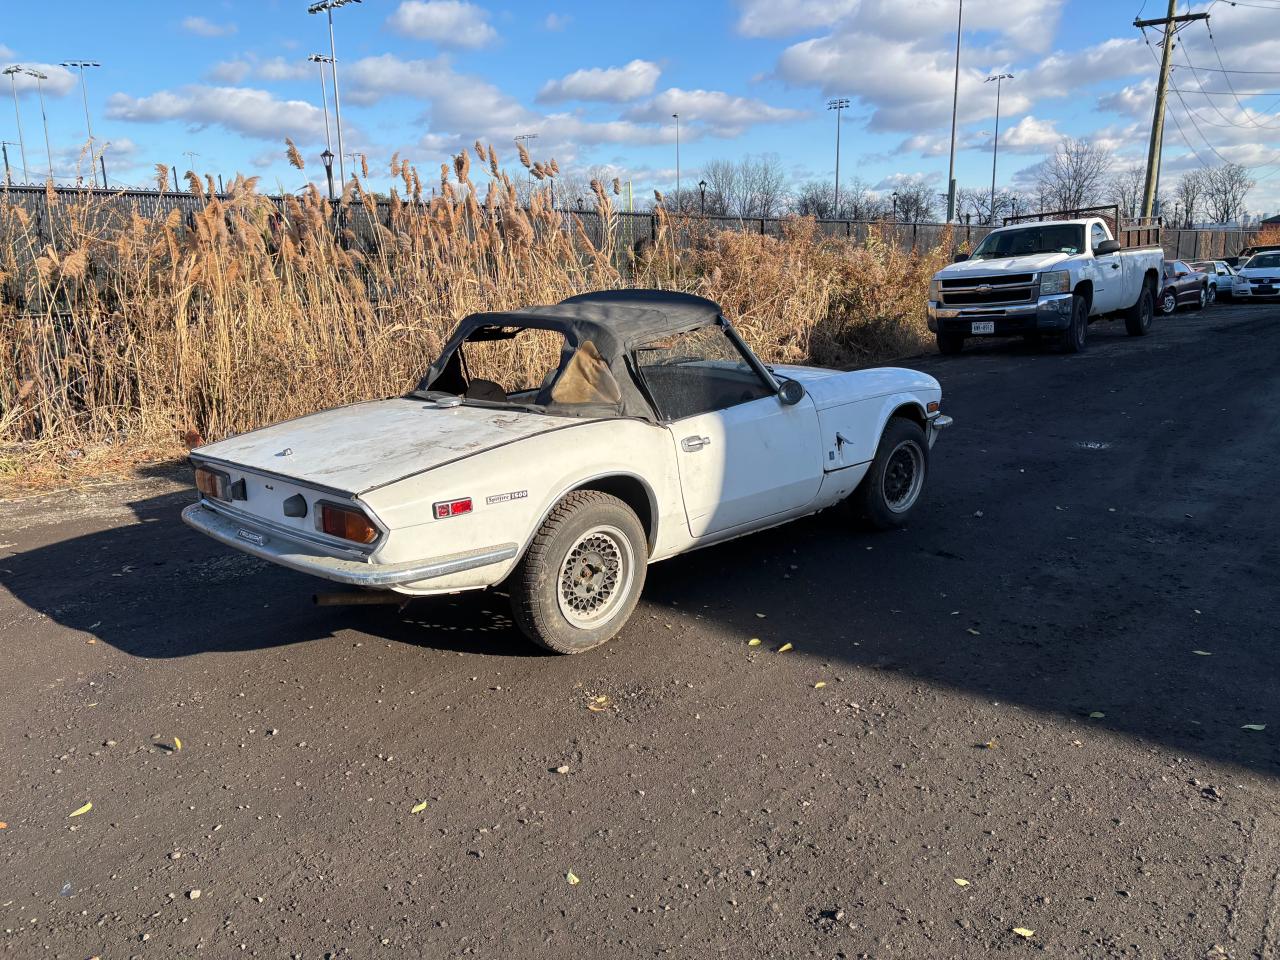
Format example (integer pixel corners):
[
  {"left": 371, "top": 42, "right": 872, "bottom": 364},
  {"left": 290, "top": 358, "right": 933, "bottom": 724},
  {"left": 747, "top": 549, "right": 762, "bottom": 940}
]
[{"left": 635, "top": 326, "right": 822, "bottom": 539}]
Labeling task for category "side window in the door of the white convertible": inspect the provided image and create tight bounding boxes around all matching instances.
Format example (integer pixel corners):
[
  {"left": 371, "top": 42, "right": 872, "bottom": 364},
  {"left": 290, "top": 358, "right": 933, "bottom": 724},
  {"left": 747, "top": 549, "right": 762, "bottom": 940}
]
[{"left": 635, "top": 326, "right": 773, "bottom": 420}]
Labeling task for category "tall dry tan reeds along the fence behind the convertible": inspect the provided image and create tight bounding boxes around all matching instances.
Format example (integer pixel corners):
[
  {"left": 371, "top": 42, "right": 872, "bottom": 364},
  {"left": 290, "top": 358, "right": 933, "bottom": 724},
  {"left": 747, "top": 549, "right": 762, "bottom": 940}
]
[{"left": 0, "top": 150, "right": 941, "bottom": 496}]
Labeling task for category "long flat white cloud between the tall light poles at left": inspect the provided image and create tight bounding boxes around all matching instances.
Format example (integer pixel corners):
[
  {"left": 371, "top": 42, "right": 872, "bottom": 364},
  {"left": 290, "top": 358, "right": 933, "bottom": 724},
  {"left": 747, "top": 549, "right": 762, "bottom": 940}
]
[{"left": 106, "top": 84, "right": 324, "bottom": 141}]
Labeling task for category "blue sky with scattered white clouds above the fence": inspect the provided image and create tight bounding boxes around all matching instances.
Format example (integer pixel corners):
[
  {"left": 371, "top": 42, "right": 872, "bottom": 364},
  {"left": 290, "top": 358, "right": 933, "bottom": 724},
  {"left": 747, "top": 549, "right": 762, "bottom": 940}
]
[{"left": 0, "top": 0, "right": 1280, "bottom": 211}]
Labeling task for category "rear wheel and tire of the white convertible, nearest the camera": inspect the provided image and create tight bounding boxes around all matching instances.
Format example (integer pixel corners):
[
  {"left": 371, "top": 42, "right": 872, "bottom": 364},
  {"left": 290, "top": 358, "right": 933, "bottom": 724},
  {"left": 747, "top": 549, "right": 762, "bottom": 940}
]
[{"left": 508, "top": 490, "right": 649, "bottom": 654}]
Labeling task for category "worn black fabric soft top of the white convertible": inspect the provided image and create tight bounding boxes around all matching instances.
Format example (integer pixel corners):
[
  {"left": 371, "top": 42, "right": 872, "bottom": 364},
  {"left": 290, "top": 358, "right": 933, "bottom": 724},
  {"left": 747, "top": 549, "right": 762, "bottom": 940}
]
[{"left": 419, "top": 289, "right": 723, "bottom": 420}]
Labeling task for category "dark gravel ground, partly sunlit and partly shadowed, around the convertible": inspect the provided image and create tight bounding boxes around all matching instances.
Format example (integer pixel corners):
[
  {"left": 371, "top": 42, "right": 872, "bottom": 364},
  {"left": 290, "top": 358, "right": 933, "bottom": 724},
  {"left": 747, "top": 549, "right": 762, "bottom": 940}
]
[{"left": 0, "top": 305, "right": 1280, "bottom": 960}]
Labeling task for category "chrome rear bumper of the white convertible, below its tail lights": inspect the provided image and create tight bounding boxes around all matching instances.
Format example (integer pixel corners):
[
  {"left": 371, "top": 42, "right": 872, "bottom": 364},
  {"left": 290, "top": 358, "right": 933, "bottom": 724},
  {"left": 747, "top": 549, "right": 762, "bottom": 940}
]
[{"left": 182, "top": 503, "right": 518, "bottom": 588}]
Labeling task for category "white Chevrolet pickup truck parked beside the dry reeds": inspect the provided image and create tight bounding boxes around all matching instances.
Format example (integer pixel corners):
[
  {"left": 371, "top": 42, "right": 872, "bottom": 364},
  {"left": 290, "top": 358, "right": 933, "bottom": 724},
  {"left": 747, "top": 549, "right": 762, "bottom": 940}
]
[{"left": 928, "top": 216, "right": 1165, "bottom": 353}]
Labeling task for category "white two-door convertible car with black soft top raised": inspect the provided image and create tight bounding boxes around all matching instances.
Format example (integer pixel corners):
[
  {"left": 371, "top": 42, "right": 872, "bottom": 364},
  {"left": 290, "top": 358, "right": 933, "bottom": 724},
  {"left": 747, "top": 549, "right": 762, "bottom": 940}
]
[{"left": 183, "top": 291, "right": 951, "bottom": 653}]
